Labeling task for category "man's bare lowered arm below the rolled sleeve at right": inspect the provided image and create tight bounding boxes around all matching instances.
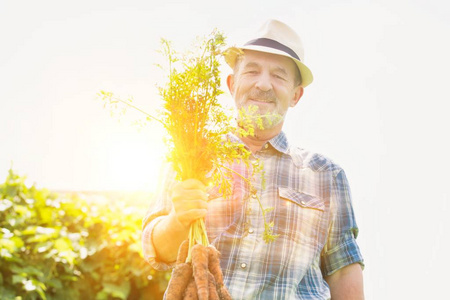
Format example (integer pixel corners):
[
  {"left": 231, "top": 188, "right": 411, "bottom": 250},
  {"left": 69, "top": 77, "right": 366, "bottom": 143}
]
[{"left": 325, "top": 263, "right": 364, "bottom": 300}]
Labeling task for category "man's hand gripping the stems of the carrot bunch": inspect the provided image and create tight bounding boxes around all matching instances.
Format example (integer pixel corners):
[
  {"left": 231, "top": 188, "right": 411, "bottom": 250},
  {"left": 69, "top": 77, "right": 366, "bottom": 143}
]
[{"left": 171, "top": 179, "right": 208, "bottom": 228}]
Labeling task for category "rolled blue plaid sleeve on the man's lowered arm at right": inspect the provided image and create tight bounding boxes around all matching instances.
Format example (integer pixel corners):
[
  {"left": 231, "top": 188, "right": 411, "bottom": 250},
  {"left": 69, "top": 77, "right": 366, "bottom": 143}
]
[{"left": 322, "top": 170, "right": 364, "bottom": 276}]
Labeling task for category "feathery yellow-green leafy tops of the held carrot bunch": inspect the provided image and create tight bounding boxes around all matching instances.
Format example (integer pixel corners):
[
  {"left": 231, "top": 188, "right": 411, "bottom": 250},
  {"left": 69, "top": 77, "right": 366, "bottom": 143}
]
[{"left": 100, "top": 31, "right": 276, "bottom": 247}]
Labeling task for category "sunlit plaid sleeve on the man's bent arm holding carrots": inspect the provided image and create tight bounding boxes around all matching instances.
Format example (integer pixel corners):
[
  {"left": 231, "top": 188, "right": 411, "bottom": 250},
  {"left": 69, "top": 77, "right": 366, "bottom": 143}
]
[{"left": 142, "top": 165, "right": 176, "bottom": 271}]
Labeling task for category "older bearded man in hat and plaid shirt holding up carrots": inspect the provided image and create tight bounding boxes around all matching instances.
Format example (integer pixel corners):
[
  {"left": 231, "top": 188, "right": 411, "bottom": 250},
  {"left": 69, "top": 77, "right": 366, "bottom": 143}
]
[{"left": 143, "top": 20, "right": 364, "bottom": 300}]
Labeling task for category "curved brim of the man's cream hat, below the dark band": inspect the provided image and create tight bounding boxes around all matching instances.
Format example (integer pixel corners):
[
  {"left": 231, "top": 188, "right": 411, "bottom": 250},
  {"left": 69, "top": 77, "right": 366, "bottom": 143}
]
[{"left": 223, "top": 45, "right": 314, "bottom": 87}]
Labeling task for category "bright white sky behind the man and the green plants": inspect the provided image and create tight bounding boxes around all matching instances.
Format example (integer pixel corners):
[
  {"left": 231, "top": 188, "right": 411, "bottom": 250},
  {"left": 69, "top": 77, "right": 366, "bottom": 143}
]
[{"left": 0, "top": 0, "right": 450, "bottom": 300}]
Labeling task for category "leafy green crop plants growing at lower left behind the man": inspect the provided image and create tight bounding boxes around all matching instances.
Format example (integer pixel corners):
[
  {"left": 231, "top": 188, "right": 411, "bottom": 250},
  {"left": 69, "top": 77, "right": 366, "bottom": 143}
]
[{"left": 0, "top": 170, "right": 170, "bottom": 300}]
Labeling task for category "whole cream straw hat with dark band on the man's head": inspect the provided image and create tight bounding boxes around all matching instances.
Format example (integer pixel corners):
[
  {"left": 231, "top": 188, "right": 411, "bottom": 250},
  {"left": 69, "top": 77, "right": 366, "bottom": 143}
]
[{"left": 224, "top": 20, "right": 313, "bottom": 87}]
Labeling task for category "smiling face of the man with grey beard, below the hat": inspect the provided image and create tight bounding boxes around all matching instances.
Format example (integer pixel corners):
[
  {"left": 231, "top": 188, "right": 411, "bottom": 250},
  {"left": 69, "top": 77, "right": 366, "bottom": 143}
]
[{"left": 227, "top": 50, "right": 303, "bottom": 129}]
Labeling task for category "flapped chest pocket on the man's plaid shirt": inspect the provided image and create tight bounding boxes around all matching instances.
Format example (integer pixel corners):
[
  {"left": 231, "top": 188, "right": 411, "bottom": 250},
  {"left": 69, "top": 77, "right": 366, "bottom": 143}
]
[{"left": 275, "top": 187, "right": 325, "bottom": 247}]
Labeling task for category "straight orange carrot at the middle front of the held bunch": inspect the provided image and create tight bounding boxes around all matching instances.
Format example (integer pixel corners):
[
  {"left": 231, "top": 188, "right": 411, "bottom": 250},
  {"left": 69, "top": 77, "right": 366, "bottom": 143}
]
[{"left": 191, "top": 244, "right": 209, "bottom": 300}]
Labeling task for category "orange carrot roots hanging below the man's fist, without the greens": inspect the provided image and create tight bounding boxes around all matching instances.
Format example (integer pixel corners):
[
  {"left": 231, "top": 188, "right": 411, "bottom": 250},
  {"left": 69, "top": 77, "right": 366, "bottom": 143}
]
[{"left": 166, "top": 240, "right": 231, "bottom": 300}]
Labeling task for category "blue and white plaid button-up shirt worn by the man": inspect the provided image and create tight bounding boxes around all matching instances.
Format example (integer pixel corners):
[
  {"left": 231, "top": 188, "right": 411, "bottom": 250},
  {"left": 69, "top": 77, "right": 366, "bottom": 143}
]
[{"left": 143, "top": 133, "right": 363, "bottom": 299}]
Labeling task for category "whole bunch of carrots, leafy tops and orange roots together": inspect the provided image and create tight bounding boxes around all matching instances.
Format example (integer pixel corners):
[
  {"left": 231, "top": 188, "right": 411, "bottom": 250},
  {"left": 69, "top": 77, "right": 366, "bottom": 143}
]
[{"left": 100, "top": 32, "right": 275, "bottom": 300}]
